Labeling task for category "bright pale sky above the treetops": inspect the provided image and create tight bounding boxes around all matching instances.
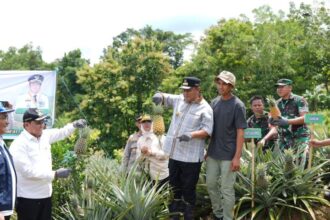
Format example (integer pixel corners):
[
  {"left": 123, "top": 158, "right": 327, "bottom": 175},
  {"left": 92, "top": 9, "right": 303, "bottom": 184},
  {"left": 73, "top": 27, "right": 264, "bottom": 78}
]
[{"left": 0, "top": 0, "right": 330, "bottom": 64}]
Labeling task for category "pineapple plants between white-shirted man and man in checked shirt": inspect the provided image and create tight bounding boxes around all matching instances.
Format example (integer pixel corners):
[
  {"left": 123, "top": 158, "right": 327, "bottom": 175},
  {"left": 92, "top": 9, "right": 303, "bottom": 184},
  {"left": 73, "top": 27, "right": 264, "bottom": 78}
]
[{"left": 56, "top": 154, "right": 169, "bottom": 220}]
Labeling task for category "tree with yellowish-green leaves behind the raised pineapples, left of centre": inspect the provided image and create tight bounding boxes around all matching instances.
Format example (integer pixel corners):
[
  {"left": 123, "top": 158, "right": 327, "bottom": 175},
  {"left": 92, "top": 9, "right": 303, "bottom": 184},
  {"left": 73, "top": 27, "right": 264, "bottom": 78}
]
[{"left": 78, "top": 37, "right": 172, "bottom": 152}]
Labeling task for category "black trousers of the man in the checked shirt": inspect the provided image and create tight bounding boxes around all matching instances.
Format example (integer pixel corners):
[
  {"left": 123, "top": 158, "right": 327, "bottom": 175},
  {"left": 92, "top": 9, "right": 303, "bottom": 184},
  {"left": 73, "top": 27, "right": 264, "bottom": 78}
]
[{"left": 168, "top": 159, "right": 202, "bottom": 205}]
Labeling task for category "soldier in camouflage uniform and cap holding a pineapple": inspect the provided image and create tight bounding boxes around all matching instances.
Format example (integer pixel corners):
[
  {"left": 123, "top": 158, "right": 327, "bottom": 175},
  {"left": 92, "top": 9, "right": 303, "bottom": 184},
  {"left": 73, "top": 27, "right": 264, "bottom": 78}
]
[{"left": 270, "top": 79, "right": 310, "bottom": 165}]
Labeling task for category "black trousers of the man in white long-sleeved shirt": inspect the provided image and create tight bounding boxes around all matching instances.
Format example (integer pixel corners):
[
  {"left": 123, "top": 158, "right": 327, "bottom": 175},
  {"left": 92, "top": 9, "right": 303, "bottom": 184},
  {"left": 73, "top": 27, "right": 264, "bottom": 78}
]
[{"left": 16, "top": 197, "right": 52, "bottom": 220}]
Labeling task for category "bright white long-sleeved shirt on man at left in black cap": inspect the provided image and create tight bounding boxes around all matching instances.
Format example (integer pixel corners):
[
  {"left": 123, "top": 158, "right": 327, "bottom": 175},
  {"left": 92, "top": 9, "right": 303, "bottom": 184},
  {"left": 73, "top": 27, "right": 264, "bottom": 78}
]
[{"left": 9, "top": 123, "right": 75, "bottom": 199}]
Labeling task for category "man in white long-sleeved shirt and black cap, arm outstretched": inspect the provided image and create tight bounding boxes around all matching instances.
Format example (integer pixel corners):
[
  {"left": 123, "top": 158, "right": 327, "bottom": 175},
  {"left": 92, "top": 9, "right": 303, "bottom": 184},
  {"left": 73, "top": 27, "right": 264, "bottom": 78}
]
[{"left": 10, "top": 108, "right": 86, "bottom": 220}]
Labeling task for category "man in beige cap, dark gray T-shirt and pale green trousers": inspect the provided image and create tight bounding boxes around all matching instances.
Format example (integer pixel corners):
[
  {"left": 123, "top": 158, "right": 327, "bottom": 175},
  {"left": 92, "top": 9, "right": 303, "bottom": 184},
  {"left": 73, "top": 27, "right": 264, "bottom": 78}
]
[{"left": 206, "top": 71, "right": 247, "bottom": 220}]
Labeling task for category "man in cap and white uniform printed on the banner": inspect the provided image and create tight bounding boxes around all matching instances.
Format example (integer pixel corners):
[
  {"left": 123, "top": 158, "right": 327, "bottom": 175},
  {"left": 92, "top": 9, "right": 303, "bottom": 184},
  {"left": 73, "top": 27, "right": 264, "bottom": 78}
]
[{"left": 15, "top": 74, "right": 49, "bottom": 109}]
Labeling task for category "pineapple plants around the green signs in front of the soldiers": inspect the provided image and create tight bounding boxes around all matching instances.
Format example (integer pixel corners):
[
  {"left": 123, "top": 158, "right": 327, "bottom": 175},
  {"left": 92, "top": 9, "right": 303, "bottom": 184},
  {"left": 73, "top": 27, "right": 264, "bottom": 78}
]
[{"left": 235, "top": 144, "right": 330, "bottom": 220}]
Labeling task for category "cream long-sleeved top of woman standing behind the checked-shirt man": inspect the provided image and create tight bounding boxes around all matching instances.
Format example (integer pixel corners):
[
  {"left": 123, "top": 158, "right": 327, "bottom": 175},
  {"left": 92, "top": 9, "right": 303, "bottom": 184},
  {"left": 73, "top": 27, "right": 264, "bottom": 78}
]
[{"left": 137, "top": 132, "right": 169, "bottom": 180}]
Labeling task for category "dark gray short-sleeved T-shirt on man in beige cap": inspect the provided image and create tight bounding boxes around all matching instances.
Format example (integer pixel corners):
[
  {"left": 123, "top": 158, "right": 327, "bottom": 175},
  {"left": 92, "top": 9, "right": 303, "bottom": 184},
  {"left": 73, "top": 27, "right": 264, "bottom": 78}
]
[{"left": 208, "top": 96, "right": 247, "bottom": 160}]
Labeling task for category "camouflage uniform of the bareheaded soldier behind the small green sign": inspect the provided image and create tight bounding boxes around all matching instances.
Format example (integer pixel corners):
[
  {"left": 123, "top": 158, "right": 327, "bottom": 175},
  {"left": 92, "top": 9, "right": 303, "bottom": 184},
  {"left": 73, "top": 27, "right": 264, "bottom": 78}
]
[{"left": 247, "top": 111, "right": 276, "bottom": 150}]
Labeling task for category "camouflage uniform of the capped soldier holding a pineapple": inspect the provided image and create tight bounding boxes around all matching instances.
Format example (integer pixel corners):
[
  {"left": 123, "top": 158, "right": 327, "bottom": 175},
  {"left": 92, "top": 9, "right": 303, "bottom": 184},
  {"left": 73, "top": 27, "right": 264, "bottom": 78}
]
[{"left": 277, "top": 93, "right": 310, "bottom": 162}]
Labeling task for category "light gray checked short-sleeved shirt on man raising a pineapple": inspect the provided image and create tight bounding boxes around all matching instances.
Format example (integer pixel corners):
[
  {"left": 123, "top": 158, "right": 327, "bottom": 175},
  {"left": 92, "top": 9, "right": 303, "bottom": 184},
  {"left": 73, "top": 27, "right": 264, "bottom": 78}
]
[{"left": 163, "top": 93, "right": 213, "bottom": 162}]
